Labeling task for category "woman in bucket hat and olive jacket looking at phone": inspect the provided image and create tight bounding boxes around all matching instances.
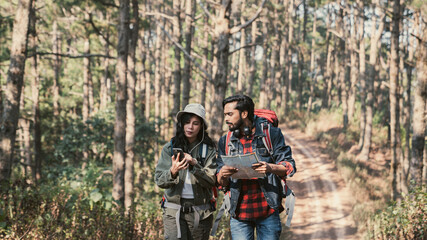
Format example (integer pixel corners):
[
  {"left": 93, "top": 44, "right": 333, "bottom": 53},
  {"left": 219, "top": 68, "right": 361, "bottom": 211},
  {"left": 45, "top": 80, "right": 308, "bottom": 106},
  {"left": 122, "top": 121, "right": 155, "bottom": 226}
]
[{"left": 155, "top": 104, "right": 217, "bottom": 239}]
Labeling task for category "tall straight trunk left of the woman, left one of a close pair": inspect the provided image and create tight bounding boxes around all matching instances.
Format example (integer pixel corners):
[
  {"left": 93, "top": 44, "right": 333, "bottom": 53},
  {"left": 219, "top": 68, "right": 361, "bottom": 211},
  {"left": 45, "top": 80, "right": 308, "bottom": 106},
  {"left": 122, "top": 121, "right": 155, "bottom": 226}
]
[{"left": 113, "top": 0, "right": 129, "bottom": 207}]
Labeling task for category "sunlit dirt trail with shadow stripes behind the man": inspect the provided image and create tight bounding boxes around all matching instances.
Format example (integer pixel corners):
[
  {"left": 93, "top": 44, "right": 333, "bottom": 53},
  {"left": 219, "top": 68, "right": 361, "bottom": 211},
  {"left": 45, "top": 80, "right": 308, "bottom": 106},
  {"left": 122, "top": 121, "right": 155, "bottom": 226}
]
[{"left": 281, "top": 126, "right": 360, "bottom": 240}]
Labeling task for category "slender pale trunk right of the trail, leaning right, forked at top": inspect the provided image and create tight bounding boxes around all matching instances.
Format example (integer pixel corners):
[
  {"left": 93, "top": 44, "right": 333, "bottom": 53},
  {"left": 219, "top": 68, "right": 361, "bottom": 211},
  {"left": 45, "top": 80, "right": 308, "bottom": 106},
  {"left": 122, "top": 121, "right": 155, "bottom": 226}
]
[{"left": 359, "top": 0, "right": 384, "bottom": 161}]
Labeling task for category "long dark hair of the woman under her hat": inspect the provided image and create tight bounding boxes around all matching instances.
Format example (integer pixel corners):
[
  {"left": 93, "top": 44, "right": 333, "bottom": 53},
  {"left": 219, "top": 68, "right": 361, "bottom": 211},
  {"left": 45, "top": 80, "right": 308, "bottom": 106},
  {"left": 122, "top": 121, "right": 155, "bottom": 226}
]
[{"left": 172, "top": 113, "right": 216, "bottom": 149}]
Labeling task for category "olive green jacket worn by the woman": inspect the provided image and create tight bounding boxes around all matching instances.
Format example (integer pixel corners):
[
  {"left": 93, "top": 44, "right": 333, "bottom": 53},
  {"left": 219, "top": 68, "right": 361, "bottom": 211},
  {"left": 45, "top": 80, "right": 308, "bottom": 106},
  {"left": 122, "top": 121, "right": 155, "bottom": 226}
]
[{"left": 155, "top": 141, "right": 217, "bottom": 219}]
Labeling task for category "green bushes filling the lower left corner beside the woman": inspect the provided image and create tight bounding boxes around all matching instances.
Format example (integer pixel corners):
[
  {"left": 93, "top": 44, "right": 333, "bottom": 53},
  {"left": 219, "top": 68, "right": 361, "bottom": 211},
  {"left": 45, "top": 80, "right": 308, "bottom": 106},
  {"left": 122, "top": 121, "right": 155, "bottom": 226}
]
[{"left": 0, "top": 163, "right": 162, "bottom": 239}]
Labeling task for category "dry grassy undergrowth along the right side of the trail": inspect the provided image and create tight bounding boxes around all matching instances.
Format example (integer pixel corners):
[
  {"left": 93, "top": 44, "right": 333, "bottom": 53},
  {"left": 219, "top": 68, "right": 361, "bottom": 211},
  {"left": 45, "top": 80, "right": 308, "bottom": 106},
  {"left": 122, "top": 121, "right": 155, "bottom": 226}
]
[{"left": 287, "top": 109, "right": 427, "bottom": 239}]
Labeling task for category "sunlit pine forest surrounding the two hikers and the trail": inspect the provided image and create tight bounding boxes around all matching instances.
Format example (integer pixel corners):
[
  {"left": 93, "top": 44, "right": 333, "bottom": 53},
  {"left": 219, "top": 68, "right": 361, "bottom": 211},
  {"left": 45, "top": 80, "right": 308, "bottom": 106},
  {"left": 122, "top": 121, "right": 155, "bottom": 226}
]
[{"left": 0, "top": 0, "right": 427, "bottom": 239}]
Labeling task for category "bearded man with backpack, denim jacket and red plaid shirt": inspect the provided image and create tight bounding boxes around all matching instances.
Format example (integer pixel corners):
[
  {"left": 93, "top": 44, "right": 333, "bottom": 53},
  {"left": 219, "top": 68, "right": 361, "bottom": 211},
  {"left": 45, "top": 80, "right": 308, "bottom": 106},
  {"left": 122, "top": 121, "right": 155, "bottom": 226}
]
[{"left": 217, "top": 95, "right": 296, "bottom": 240}]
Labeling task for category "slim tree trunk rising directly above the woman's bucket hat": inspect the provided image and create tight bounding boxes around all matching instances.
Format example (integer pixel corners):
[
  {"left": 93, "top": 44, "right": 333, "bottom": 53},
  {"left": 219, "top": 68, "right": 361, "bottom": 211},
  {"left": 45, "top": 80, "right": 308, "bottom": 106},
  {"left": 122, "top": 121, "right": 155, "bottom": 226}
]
[{"left": 182, "top": 0, "right": 196, "bottom": 106}]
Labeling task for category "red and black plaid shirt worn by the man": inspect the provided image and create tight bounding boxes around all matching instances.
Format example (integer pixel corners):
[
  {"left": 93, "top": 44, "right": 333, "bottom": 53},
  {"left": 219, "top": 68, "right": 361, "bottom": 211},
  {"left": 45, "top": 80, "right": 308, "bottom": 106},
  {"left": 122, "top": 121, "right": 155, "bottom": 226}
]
[{"left": 236, "top": 135, "right": 276, "bottom": 220}]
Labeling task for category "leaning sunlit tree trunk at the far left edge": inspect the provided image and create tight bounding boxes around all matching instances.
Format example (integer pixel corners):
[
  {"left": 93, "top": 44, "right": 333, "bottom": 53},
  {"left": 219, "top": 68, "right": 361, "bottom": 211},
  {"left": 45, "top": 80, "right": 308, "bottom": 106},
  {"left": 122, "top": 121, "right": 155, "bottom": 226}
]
[{"left": 0, "top": 0, "right": 33, "bottom": 187}]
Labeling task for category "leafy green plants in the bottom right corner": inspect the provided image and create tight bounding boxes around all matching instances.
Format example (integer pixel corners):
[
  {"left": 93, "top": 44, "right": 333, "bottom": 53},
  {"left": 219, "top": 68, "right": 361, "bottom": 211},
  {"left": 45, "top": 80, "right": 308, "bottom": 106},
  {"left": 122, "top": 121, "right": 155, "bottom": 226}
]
[{"left": 369, "top": 187, "right": 427, "bottom": 239}]
